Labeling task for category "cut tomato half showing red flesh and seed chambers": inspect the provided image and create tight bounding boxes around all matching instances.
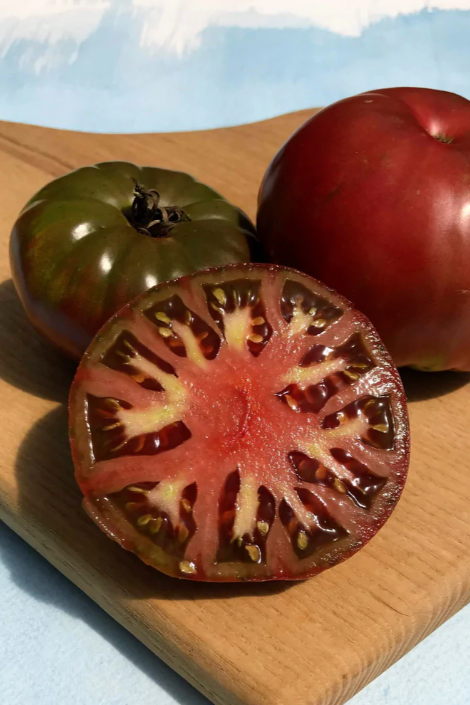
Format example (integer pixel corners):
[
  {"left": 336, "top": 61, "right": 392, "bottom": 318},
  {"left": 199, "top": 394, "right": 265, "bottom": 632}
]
[{"left": 70, "top": 264, "right": 409, "bottom": 581}]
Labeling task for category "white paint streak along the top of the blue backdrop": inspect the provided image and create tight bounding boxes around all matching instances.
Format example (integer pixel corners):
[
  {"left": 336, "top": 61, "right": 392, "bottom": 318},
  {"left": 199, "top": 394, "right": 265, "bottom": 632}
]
[{"left": 0, "top": 0, "right": 470, "bottom": 59}]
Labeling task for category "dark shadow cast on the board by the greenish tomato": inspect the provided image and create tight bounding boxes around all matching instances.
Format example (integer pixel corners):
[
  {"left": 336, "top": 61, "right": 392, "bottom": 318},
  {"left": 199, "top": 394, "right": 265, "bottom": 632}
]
[{"left": 0, "top": 279, "right": 76, "bottom": 402}]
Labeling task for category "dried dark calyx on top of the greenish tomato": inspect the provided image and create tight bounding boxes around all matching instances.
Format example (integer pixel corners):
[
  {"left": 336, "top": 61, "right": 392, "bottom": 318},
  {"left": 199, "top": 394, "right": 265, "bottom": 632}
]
[{"left": 127, "top": 182, "right": 190, "bottom": 238}]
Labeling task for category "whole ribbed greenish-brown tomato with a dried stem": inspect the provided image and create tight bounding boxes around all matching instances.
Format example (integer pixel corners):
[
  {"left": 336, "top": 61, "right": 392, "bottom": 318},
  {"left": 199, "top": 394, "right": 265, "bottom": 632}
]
[{"left": 10, "top": 162, "right": 256, "bottom": 358}]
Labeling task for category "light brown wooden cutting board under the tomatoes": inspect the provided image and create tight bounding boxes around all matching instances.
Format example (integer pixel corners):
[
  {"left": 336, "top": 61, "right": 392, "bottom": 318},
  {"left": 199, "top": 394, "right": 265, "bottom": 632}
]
[{"left": 0, "top": 112, "right": 470, "bottom": 705}]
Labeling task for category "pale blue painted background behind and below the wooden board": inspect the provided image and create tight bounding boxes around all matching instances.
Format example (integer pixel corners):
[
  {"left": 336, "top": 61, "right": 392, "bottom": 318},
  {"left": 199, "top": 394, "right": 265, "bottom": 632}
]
[{"left": 0, "top": 0, "right": 470, "bottom": 705}]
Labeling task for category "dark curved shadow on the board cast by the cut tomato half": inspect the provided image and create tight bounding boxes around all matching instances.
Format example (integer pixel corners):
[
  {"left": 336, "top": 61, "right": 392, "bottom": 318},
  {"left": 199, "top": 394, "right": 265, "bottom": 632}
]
[{"left": 15, "top": 406, "right": 293, "bottom": 600}]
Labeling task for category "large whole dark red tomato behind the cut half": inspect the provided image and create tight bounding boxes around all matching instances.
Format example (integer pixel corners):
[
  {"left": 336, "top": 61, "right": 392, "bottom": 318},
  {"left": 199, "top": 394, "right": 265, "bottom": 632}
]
[{"left": 258, "top": 88, "right": 470, "bottom": 371}]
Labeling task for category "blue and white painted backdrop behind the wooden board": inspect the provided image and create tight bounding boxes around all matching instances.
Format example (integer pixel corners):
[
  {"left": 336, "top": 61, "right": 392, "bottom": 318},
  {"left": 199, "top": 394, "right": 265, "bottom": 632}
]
[{"left": 0, "top": 0, "right": 470, "bottom": 132}]
